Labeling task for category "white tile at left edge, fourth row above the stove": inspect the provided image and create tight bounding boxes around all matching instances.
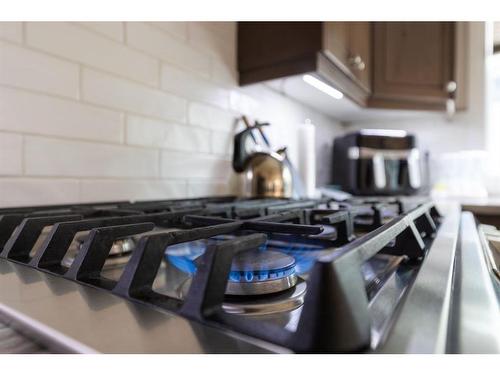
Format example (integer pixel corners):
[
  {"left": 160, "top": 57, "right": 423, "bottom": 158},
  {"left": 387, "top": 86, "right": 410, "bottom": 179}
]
[{"left": 0, "top": 42, "right": 79, "bottom": 99}]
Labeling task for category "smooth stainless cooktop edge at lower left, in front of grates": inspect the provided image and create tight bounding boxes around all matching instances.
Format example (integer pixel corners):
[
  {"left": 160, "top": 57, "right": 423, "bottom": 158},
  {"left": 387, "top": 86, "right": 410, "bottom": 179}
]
[{"left": 0, "top": 259, "right": 284, "bottom": 353}]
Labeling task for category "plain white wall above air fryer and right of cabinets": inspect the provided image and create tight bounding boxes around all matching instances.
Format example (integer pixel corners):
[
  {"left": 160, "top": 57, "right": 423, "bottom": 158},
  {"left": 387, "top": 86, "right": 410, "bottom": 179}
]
[{"left": 346, "top": 22, "right": 486, "bottom": 156}]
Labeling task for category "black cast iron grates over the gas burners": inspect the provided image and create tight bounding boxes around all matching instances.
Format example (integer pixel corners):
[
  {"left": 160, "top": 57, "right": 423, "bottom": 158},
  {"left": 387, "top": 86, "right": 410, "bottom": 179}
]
[{"left": 0, "top": 197, "right": 439, "bottom": 352}]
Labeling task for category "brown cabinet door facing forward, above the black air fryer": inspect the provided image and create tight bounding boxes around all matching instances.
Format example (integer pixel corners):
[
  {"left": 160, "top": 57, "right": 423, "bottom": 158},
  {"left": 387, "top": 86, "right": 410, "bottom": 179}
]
[{"left": 369, "top": 22, "right": 455, "bottom": 109}]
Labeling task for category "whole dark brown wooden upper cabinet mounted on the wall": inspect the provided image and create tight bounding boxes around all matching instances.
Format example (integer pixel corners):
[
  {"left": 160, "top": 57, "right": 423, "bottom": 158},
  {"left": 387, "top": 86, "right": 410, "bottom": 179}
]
[{"left": 238, "top": 22, "right": 466, "bottom": 110}]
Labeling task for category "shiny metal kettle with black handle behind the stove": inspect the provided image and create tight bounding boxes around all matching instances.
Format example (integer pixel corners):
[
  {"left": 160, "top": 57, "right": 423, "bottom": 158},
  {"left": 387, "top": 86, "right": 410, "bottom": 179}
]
[{"left": 233, "top": 124, "right": 293, "bottom": 198}]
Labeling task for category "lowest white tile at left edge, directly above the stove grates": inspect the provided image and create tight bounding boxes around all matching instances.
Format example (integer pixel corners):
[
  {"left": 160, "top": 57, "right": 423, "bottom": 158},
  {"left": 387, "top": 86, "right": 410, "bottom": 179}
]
[{"left": 0, "top": 177, "right": 80, "bottom": 207}]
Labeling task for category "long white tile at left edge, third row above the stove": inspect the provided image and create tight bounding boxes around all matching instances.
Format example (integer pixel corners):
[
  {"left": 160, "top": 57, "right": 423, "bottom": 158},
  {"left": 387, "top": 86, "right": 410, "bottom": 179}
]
[{"left": 0, "top": 87, "right": 123, "bottom": 142}]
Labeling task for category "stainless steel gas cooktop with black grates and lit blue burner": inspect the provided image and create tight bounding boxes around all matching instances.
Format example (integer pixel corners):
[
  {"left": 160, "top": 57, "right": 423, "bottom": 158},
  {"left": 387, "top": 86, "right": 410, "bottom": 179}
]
[{"left": 0, "top": 197, "right": 500, "bottom": 353}]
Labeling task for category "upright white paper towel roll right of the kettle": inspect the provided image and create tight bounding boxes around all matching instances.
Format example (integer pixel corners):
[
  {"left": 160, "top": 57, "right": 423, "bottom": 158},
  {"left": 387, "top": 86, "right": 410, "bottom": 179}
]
[{"left": 298, "top": 120, "right": 316, "bottom": 198}]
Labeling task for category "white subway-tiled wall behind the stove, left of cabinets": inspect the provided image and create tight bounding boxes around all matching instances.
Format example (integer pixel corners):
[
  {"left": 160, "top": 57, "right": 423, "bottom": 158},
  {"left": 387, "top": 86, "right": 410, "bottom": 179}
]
[{"left": 0, "top": 22, "right": 340, "bottom": 206}]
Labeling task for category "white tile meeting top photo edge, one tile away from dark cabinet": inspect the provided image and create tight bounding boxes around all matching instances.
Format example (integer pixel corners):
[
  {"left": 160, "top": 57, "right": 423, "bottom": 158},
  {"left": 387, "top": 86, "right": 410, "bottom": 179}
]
[{"left": 127, "top": 22, "right": 210, "bottom": 77}]
